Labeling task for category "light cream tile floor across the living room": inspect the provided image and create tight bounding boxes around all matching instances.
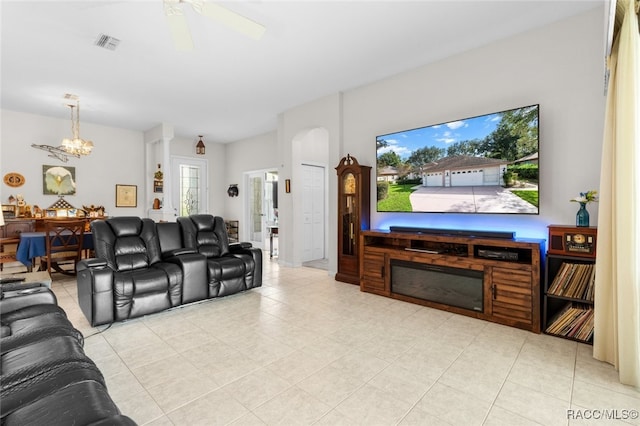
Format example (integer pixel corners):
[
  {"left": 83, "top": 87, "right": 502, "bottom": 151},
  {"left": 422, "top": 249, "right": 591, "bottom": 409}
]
[{"left": 43, "top": 256, "right": 640, "bottom": 426}]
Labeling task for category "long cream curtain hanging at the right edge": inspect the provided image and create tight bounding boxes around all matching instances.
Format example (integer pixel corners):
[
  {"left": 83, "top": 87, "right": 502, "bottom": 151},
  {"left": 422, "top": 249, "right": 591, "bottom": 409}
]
[{"left": 593, "top": 0, "right": 640, "bottom": 387}]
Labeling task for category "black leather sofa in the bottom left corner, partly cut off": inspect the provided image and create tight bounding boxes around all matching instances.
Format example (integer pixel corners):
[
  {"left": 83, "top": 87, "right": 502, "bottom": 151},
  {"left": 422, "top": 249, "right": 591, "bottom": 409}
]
[{"left": 0, "top": 285, "right": 136, "bottom": 426}]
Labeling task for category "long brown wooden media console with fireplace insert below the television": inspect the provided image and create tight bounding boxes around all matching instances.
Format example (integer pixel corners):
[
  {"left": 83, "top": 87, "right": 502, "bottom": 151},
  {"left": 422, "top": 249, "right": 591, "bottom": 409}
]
[{"left": 360, "top": 230, "right": 545, "bottom": 333}]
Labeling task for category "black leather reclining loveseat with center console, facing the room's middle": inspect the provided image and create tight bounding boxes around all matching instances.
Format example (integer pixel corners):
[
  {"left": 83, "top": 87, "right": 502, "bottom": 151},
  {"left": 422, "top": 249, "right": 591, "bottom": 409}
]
[{"left": 77, "top": 214, "right": 262, "bottom": 326}]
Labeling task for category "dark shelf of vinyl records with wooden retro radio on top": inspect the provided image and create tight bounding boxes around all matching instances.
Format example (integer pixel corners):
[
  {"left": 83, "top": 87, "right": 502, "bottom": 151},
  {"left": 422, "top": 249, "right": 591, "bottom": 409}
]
[{"left": 542, "top": 225, "right": 597, "bottom": 344}]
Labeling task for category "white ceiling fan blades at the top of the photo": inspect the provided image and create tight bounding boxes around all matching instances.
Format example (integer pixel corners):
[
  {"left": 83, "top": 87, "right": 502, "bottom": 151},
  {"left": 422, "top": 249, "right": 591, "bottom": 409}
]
[{"left": 163, "top": 0, "right": 266, "bottom": 51}]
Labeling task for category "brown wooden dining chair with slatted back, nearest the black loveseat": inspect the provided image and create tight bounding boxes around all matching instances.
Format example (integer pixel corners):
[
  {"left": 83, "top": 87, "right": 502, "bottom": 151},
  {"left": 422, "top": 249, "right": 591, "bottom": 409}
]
[{"left": 40, "top": 219, "right": 86, "bottom": 275}]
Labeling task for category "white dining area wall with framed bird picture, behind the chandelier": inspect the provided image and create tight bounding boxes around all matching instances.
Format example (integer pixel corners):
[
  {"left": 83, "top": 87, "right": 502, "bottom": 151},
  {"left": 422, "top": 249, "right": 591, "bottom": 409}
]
[{"left": 0, "top": 110, "right": 146, "bottom": 216}]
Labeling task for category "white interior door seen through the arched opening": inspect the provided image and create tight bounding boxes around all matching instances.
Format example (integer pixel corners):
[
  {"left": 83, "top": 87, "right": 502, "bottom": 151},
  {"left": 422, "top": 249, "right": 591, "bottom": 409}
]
[{"left": 301, "top": 164, "right": 325, "bottom": 262}]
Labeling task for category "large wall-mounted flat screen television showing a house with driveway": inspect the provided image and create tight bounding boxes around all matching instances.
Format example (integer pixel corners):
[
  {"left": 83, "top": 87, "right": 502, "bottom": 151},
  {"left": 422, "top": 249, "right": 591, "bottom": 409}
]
[{"left": 376, "top": 105, "right": 539, "bottom": 215}]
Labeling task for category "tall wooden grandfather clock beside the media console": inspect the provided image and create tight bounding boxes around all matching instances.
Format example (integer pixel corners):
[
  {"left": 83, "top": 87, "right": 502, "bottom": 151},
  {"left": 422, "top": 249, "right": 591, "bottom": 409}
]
[{"left": 336, "top": 154, "right": 371, "bottom": 285}]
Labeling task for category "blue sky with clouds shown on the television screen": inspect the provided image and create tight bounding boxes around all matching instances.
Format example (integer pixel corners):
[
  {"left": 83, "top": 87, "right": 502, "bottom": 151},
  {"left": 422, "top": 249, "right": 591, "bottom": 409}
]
[{"left": 377, "top": 113, "right": 500, "bottom": 160}]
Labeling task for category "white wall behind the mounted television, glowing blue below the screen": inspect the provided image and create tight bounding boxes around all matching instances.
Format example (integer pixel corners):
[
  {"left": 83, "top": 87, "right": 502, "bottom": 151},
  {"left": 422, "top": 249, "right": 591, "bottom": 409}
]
[{"left": 343, "top": 5, "right": 605, "bottom": 238}]
